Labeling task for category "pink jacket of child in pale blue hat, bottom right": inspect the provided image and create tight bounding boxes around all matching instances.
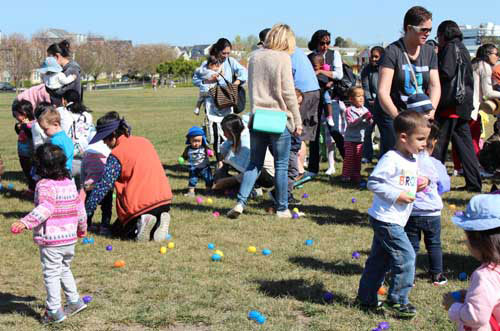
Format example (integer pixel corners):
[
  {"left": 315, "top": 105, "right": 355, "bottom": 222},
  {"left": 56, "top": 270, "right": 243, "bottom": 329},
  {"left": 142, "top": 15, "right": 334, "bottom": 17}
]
[{"left": 448, "top": 264, "right": 500, "bottom": 331}]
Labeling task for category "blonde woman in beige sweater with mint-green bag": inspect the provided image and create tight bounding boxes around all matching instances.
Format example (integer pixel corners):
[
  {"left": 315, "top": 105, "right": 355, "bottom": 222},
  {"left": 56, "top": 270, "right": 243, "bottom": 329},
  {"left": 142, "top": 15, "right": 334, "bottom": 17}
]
[{"left": 228, "top": 24, "right": 302, "bottom": 218}]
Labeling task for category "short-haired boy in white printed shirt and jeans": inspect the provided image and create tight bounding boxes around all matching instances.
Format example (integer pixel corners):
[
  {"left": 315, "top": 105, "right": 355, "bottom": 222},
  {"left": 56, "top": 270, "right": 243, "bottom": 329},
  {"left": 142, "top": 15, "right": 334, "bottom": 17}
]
[{"left": 358, "top": 111, "right": 430, "bottom": 318}]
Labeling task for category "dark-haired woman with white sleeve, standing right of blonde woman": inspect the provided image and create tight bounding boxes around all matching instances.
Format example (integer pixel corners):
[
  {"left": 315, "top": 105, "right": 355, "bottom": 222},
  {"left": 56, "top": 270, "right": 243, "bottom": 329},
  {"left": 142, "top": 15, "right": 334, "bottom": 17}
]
[{"left": 305, "top": 30, "right": 344, "bottom": 177}]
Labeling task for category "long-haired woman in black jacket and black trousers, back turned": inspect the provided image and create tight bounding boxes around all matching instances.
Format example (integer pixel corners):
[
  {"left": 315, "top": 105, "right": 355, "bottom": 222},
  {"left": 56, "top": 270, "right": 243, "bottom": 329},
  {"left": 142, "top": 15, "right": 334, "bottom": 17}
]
[{"left": 434, "top": 21, "right": 481, "bottom": 192}]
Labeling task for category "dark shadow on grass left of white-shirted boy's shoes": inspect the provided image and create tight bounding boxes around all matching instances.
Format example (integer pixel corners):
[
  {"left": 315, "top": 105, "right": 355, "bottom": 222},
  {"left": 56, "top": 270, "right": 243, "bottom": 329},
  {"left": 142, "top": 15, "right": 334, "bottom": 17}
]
[{"left": 255, "top": 279, "right": 352, "bottom": 307}]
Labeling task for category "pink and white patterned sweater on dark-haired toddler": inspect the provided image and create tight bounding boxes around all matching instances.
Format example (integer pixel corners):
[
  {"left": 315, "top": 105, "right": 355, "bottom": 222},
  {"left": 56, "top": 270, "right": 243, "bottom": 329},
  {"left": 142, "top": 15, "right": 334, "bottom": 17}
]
[{"left": 21, "top": 179, "right": 87, "bottom": 246}]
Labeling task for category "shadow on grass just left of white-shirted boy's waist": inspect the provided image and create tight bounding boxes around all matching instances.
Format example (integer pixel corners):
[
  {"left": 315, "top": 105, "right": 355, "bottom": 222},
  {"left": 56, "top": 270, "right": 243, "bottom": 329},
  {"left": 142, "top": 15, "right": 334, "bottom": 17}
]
[{"left": 294, "top": 205, "right": 370, "bottom": 227}]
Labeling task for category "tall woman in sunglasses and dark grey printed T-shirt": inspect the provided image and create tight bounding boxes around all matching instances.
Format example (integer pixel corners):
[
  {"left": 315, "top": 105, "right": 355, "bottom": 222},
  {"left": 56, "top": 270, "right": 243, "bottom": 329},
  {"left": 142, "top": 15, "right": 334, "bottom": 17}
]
[{"left": 373, "top": 6, "right": 441, "bottom": 155}]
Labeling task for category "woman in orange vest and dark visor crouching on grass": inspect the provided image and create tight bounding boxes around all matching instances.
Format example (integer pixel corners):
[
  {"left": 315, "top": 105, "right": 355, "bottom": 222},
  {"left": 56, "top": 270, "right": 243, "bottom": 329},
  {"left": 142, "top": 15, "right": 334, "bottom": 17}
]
[{"left": 85, "top": 112, "right": 172, "bottom": 241}]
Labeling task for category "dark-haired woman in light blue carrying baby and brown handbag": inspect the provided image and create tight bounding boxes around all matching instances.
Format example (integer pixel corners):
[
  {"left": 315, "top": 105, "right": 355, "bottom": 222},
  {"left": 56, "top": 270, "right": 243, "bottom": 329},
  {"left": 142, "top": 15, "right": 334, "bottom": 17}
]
[{"left": 193, "top": 38, "right": 248, "bottom": 165}]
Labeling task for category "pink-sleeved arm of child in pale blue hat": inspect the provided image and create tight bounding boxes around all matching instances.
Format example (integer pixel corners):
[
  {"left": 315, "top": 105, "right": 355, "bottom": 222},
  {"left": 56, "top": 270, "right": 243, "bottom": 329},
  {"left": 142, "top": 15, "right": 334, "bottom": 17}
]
[{"left": 448, "top": 272, "right": 499, "bottom": 329}]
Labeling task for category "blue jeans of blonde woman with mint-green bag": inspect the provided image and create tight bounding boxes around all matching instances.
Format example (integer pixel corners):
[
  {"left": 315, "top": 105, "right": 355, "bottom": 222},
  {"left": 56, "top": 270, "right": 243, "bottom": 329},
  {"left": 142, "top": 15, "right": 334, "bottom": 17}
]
[{"left": 238, "top": 129, "right": 291, "bottom": 211}]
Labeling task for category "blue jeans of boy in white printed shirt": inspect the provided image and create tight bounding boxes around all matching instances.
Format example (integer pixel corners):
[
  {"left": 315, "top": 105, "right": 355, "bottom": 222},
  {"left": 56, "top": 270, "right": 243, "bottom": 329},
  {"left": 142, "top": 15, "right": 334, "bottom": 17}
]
[{"left": 358, "top": 217, "right": 415, "bottom": 304}]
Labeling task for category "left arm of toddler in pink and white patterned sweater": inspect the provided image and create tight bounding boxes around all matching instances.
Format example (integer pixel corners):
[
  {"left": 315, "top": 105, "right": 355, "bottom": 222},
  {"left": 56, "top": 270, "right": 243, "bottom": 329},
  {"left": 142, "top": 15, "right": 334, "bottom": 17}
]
[{"left": 19, "top": 181, "right": 56, "bottom": 230}]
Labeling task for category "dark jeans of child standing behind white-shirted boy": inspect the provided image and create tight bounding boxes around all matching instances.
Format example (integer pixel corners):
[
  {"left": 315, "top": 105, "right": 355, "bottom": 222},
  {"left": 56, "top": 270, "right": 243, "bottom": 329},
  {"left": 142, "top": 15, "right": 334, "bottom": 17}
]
[{"left": 405, "top": 216, "right": 443, "bottom": 274}]
